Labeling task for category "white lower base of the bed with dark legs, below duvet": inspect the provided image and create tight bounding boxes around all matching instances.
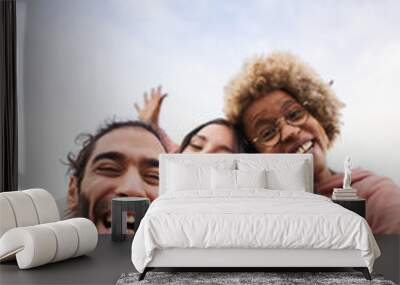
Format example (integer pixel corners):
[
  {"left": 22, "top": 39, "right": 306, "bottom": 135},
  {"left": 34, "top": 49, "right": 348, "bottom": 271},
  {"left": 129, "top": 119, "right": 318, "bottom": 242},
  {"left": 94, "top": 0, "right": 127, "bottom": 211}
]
[{"left": 139, "top": 248, "right": 371, "bottom": 280}]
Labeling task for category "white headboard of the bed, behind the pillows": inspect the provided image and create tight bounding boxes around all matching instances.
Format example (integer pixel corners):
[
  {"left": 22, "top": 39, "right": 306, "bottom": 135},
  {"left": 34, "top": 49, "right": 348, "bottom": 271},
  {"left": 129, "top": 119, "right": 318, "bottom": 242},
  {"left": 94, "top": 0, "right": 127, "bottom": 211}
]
[{"left": 159, "top": 153, "right": 314, "bottom": 195}]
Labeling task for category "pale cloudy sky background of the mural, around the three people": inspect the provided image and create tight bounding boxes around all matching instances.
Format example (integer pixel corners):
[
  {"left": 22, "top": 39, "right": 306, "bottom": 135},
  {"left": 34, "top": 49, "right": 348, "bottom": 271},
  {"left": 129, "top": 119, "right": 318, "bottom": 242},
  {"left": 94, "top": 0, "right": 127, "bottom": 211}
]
[{"left": 17, "top": 0, "right": 400, "bottom": 198}]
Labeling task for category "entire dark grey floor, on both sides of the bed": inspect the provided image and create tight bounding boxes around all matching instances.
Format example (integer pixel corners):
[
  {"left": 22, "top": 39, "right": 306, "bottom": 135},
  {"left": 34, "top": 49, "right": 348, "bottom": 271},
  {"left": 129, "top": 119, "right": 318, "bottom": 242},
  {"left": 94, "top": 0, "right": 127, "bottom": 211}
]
[{"left": 0, "top": 236, "right": 400, "bottom": 285}]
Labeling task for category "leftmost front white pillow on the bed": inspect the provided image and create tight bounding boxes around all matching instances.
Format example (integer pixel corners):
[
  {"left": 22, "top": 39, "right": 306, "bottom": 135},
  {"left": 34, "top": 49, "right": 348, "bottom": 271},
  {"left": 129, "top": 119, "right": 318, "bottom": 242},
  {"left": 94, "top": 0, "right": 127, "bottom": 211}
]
[{"left": 167, "top": 163, "right": 210, "bottom": 191}]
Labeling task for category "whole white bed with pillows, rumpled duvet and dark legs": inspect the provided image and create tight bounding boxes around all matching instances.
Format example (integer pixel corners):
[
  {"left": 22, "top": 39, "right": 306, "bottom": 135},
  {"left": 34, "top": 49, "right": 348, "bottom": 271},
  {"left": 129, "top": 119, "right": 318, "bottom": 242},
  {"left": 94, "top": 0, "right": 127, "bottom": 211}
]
[{"left": 132, "top": 154, "right": 380, "bottom": 280}]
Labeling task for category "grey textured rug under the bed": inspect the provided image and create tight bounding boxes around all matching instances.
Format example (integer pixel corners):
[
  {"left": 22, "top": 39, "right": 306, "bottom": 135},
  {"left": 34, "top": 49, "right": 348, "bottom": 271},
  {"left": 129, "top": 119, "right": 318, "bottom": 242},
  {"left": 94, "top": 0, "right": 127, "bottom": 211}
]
[{"left": 117, "top": 271, "right": 395, "bottom": 285}]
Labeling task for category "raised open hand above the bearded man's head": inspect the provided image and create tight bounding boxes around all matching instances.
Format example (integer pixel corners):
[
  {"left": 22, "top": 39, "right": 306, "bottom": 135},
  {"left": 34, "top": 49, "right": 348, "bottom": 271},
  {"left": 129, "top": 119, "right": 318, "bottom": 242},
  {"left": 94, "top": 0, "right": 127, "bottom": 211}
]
[{"left": 134, "top": 85, "right": 168, "bottom": 128}]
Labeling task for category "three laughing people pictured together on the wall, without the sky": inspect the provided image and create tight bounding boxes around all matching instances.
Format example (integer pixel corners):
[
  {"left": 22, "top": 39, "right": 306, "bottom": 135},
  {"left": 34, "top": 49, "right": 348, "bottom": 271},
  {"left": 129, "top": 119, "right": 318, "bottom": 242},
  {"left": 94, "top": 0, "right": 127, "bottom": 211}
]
[{"left": 64, "top": 52, "right": 400, "bottom": 234}]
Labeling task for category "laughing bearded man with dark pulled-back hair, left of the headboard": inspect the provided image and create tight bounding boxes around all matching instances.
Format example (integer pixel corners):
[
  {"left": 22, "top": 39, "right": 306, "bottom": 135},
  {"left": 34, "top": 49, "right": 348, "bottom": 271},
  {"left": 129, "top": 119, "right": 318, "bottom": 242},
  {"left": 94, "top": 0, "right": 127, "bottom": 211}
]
[{"left": 68, "top": 121, "right": 166, "bottom": 234}]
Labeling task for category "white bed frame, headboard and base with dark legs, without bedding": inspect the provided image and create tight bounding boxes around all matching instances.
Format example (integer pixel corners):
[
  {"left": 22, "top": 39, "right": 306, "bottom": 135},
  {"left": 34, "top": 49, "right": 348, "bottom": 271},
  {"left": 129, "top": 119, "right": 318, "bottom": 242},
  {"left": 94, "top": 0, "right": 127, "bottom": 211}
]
[{"left": 139, "top": 154, "right": 371, "bottom": 280}]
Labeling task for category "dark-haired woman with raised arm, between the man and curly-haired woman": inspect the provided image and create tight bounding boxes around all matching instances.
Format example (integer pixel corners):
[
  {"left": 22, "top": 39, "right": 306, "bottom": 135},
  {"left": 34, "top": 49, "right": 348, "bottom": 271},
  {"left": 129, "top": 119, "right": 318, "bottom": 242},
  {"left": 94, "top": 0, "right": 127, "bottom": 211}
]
[{"left": 135, "top": 86, "right": 243, "bottom": 153}]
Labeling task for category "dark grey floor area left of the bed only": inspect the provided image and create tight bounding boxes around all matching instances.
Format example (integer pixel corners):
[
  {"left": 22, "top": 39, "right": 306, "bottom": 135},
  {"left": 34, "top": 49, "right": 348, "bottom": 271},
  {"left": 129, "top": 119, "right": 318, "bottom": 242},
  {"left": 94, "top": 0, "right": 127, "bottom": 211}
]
[{"left": 0, "top": 235, "right": 134, "bottom": 285}]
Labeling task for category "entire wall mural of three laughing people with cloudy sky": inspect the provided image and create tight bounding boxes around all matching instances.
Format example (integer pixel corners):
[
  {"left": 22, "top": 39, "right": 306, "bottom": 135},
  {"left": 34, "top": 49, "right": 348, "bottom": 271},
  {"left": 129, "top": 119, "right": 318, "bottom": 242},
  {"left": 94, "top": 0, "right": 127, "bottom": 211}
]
[{"left": 16, "top": 0, "right": 400, "bottom": 234}]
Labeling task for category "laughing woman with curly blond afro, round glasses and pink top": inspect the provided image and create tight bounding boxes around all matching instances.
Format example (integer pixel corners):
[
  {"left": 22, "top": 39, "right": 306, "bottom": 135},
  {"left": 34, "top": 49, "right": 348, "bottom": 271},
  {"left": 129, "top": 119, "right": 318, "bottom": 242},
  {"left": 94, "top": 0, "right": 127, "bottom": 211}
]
[{"left": 224, "top": 52, "right": 400, "bottom": 234}]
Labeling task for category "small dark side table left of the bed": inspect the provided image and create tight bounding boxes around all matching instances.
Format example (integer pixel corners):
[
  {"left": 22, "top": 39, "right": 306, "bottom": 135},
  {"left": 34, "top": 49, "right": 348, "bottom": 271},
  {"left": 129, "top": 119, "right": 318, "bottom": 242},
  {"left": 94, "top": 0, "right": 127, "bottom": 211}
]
[{"left": 111, "top": 197, "right": 150, "bottom": 241}]
